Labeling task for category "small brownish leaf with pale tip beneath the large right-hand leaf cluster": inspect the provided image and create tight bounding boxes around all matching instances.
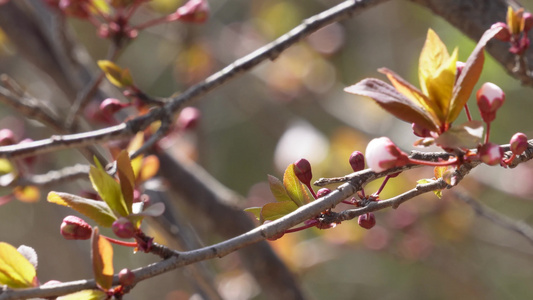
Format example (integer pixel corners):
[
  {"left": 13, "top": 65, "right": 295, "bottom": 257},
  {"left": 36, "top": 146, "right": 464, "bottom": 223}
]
[{"left": 435, "top": 120, "right": 483, "bottom": 149}]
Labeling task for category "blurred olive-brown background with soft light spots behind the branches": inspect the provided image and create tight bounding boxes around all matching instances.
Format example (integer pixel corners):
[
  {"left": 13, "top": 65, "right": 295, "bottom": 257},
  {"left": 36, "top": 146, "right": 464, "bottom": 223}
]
[{"left": 0, "top": 0, "right": 533, "bottom": 300}]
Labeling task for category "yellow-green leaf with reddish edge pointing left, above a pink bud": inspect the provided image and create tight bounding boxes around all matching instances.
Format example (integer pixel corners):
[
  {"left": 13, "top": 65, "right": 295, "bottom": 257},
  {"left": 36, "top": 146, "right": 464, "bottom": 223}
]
[{"left": 47, "top": 192, "right": 117, "bottom": 227}]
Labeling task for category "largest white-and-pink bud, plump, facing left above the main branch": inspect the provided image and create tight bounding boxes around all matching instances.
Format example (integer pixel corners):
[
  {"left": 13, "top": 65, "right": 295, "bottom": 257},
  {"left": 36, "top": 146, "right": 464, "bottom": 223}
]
[{"left": 366, "top": 137, "right": 409, "bottom": 172}]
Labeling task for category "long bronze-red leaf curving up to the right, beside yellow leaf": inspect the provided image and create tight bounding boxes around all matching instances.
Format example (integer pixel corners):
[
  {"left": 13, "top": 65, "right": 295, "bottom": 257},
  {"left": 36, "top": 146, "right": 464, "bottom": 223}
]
[{"left": 446, "top": 26, "right": 504, "bottom": 123}]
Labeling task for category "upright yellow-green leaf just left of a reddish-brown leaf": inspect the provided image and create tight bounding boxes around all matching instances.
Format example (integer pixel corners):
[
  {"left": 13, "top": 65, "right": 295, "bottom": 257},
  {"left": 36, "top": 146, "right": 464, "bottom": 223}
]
[{"left": 89, "top": 166, "right": 129, "bottom": 217}]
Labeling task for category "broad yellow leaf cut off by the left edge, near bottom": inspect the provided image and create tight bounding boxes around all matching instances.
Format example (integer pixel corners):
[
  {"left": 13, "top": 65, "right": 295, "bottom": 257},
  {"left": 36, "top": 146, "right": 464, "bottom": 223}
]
[{"left": 0, "top": 242, "right": 37, "bottom": 289}]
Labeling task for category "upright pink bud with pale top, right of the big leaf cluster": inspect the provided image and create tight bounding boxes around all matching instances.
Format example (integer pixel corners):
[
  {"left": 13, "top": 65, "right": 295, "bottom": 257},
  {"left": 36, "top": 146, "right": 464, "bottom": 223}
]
[{"left": 476, "top": 82, "right": 505, "bottom": 123}]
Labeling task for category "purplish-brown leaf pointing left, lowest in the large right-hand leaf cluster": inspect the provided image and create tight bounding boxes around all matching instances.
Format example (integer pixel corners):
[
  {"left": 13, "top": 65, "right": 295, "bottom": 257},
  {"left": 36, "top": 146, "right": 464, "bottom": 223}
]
[{"left": 344, "top": 78, "right": 437, "bottom": 131}]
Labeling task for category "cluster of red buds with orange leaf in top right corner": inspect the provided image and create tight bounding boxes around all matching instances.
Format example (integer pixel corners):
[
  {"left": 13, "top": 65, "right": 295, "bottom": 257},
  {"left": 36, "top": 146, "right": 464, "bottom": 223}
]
[{"left": 492, "top": 6, "right": 533, "bottom": 55}]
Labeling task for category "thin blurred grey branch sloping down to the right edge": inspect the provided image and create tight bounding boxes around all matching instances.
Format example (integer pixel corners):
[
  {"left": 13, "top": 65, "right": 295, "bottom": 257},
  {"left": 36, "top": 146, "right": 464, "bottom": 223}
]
[{"left": 453, "top": 190, "right": 533, "bottom": 243}]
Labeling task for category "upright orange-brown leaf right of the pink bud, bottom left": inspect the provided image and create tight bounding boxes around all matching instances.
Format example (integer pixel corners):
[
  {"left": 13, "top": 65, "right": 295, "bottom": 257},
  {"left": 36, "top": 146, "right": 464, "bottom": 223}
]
[{"left": 91, "top": 227, "right": 113, "bottom": 290}]
